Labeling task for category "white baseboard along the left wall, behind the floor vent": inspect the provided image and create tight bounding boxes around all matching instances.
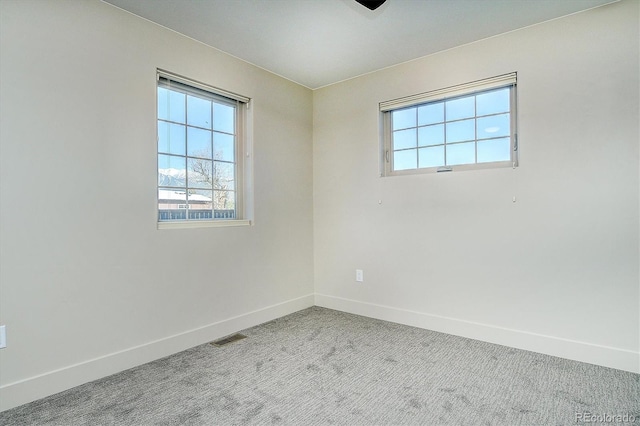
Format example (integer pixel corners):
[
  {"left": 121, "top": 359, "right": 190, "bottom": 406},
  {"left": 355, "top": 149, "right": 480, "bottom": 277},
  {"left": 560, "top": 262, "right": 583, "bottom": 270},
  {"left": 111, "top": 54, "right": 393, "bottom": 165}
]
[{"left": 0, "top": 294, "right": 314, "bottom": 411}]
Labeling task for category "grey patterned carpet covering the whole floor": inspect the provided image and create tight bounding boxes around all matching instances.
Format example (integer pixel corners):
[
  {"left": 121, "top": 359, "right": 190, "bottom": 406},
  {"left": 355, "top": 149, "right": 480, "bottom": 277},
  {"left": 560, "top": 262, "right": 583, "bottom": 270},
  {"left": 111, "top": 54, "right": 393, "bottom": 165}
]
[{"left": 0, "top": 307, "right": 640, "bottom": 426}]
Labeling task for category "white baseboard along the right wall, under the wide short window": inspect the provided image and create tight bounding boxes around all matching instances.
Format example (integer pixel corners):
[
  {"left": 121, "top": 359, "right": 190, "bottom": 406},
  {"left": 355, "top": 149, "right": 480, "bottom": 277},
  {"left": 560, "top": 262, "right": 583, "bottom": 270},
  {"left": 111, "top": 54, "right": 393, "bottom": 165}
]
[{"left": 315, "top": 293, "right": 640, "bottom": 373}]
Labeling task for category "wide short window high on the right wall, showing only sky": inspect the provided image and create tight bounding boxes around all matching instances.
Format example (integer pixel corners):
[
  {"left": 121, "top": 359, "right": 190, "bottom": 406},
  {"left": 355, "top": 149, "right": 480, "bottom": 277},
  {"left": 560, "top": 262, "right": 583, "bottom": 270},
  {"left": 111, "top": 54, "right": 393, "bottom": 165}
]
[{"left": 380, "top": 73, "right": 518, "bottom": 175}]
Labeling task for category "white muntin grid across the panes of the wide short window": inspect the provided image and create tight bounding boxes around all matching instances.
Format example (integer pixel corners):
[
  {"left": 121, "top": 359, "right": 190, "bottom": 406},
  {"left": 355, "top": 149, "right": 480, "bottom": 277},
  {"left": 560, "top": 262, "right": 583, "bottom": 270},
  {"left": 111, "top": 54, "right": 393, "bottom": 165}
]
[{"left": 386, "top": 83, "right": 517, "bottom": 173}]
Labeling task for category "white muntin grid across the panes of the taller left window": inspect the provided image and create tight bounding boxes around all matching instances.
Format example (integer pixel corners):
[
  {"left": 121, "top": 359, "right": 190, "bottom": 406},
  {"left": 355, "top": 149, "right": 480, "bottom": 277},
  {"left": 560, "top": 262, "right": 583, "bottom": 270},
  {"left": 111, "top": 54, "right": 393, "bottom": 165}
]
[{"left": 156, "top": 77, "right": 242, "bottom": 221}]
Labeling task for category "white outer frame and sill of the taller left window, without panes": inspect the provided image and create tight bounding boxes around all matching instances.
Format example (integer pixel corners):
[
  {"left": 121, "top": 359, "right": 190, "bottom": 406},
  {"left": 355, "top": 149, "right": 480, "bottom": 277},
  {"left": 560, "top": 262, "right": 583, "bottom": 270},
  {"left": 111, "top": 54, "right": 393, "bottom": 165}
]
[{"left": 155, "top": 69, "right": 253, "bottom": 229}]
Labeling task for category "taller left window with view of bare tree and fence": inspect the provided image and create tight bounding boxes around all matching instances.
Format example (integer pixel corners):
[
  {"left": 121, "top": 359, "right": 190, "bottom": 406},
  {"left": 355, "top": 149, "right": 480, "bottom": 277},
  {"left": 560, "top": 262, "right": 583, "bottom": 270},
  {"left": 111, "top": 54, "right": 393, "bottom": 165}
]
[{"left": 157, "top": 71, "right": 249, "bottom": 227}]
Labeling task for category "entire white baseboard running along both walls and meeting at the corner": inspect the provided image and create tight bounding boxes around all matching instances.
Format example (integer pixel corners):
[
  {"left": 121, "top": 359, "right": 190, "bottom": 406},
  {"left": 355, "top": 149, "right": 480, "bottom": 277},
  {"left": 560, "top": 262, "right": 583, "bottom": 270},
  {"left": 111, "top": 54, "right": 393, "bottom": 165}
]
[{"left": 0, "top": 294, "right": 640, "bottom": 411}]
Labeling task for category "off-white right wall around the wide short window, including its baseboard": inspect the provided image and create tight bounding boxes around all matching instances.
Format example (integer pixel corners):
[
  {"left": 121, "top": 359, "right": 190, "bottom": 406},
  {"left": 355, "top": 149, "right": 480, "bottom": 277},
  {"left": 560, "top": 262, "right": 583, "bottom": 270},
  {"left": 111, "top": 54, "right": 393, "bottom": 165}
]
[{"left": 313, "top": 0, "right": 640, "bottom": 372}]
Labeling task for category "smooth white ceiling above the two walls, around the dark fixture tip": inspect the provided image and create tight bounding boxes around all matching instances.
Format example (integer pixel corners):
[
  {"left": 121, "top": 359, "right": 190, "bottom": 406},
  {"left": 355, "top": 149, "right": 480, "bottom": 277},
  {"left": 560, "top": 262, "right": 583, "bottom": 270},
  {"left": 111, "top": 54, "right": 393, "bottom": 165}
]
[{"left": 104, "top": 0, "right": 617, "bottom": 89}]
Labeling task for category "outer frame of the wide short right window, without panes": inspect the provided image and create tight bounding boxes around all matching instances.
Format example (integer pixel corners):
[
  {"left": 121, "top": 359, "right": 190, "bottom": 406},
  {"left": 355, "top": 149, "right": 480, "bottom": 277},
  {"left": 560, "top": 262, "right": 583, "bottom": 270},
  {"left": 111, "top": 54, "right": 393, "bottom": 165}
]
[{"left": 379, "top": 72, "right": 518, "bottom": 177}]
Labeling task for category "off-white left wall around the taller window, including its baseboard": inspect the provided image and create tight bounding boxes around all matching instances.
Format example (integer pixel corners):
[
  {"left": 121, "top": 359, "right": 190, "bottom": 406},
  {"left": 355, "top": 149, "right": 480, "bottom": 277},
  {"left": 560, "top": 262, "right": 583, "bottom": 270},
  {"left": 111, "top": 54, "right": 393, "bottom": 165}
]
[{"left": 0, "top": 0, "right": 313, "bottom": 409}]
